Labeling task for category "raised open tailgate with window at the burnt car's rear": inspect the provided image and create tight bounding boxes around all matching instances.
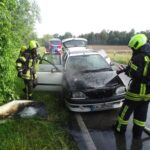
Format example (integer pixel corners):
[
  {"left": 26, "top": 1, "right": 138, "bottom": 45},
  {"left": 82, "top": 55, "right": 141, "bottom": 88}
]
[{"left": 63, "top": 40, "right": 87, "bottom": 48}]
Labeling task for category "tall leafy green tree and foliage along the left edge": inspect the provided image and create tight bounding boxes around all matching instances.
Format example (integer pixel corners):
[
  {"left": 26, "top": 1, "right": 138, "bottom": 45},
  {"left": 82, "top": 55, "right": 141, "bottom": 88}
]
[{"left": 0, "top": 0, "right": 39, "bottom": 102}]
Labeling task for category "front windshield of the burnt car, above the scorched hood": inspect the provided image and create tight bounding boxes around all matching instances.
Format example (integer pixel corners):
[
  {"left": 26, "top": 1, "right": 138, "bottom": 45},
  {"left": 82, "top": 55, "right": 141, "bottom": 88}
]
[{"left": 66, "top": 54, "right": 110, "bottom": 72}]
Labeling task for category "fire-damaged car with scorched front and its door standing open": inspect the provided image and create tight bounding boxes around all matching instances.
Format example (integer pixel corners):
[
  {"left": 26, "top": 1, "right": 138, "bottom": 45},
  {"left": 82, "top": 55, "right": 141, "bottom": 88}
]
[{"left": 37, "top": 49, "right": 125, "bottom": 112}]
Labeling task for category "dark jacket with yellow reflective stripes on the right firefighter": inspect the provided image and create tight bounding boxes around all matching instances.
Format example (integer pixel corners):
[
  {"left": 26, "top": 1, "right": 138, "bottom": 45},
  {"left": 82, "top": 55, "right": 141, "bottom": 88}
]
[{"left": 125, "top": 44, "right": 150, "bottom": 101}]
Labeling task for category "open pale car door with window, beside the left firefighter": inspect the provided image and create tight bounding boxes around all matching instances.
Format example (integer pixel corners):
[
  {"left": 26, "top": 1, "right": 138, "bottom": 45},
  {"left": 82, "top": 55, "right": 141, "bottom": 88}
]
[{"left": 35, "top": 54, "right": 63, "bottom": 91}]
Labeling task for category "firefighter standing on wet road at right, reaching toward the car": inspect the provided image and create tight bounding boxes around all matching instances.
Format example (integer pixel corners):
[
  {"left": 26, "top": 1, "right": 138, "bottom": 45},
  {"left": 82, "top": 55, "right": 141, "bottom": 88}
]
[{"left": 114, "top": 34, "right": 150, "bottom": 139}]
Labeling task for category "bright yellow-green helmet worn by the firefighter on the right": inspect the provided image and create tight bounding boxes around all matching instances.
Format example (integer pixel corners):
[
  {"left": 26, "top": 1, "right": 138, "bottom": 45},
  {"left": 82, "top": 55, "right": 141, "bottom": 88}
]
[{"left": 128, "top": 34, "right": 148, "bottom": 50}]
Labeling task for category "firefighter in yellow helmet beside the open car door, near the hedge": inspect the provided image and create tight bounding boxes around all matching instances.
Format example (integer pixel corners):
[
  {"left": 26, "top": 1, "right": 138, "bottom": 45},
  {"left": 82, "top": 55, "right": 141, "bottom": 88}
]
[{"left": 16, "top": 40, "right": 38, "bottom": 99}]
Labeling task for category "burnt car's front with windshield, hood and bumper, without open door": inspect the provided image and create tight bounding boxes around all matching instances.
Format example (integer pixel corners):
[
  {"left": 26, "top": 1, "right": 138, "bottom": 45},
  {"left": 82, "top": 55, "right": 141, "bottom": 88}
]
[{"left": 63, "top": 51, "right": 125, "bottom": 112}]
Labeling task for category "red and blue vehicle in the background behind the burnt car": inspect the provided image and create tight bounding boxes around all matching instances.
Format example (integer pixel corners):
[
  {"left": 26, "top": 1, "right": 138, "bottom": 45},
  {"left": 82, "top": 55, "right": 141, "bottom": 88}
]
[{"left": 47, "top": 38, "right": 62, "bottom": 55}]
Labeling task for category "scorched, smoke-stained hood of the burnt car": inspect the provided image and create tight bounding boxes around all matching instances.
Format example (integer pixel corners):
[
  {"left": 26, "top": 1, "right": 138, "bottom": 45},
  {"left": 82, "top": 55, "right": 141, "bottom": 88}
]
[{"left": 65, "top": 71, "right": 123, "bottom": 90}]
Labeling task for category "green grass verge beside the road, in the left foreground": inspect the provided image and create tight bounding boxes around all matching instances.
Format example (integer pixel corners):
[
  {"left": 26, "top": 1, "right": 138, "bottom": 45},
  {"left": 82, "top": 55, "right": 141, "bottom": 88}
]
[{"left": 0, "top": 90, "right": 77, "bottom": 150}]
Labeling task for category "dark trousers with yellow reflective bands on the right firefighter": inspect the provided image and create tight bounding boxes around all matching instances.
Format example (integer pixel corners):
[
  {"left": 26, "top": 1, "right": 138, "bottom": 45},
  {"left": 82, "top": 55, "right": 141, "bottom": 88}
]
[{"left": 115, "top": 99, "right": 149, "bottom": 138}]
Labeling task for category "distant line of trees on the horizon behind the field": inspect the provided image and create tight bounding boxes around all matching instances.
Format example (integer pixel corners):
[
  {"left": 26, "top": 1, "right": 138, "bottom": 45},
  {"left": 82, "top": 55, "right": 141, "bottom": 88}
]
[{"left": 39, "top": 29, "right": 150, "bottom": 46}]
